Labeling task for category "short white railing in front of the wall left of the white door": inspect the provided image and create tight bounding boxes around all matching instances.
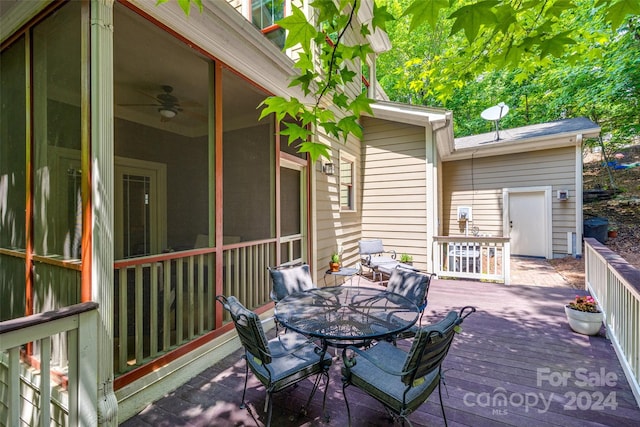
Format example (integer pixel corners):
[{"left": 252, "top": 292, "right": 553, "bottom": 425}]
[{"left": 433, "top": 236, "right": 511, "bottom": 284}]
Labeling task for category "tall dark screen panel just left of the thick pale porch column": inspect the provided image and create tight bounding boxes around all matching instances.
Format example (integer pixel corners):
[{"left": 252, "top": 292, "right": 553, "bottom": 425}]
[{"left": 33, "top": 2, "right": 82, "bottom": 259}]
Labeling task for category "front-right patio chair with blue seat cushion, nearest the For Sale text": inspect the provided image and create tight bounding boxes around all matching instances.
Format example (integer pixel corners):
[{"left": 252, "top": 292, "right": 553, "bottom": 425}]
[{"left": 342, "top": 306, "right": 476, "bottom": 426}]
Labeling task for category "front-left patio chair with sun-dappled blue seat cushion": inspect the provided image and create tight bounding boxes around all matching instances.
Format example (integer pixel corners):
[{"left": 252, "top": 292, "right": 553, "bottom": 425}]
[{"left": 216, "top": 295, "right": 331, "bottom": 426}]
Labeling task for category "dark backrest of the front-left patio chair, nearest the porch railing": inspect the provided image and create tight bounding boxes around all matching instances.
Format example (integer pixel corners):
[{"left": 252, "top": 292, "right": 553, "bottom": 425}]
[{"left": 216, "top": 295, "right": 271, "bottom": 364}]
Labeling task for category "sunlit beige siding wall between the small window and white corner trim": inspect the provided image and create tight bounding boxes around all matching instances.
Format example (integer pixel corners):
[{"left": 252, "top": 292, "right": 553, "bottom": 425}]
[{"left": 359, "top": 118, "right": 429, "bottom": 268}]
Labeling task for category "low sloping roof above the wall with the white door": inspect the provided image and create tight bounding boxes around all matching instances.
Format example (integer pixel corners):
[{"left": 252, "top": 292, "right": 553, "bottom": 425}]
[{"left": 440, "top": 117, "right": 600, "bottom": 160}]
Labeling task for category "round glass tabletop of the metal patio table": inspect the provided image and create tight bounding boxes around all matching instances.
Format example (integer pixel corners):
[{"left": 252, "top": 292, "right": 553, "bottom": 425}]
[{"left": 275, "top": 286, "right": 420, "bottom": 350}]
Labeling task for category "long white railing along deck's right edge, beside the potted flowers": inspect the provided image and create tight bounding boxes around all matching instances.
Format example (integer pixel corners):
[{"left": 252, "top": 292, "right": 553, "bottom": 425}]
[{"left": 584, "top": 238, "right": 640, "bottom": 405}]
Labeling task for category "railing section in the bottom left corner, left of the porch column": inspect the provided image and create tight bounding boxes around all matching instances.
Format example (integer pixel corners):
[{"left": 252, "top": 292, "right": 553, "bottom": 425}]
[{"left": 0, "top": 302, "right": 98, "bottom": 426}]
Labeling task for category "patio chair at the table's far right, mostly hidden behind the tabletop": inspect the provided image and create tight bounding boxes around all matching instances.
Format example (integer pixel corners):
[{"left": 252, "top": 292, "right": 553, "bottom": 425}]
[{"left": 387, "top": 266, "right": 436, "bottom": 342}]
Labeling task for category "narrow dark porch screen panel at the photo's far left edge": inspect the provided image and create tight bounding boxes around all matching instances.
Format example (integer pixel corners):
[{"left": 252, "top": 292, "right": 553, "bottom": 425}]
[{"left": 0, "top": 38, "right": 26, "bottom": 321}]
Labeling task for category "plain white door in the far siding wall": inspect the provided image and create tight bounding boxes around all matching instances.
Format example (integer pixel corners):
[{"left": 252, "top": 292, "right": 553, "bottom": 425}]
[{"left": 508, "top": 191, "right": 549, "bottom": 257}]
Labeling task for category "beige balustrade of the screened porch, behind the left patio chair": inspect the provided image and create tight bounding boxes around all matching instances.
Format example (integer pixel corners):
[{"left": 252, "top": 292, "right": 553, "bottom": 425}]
[{"left": 114, "top": 239, "right": 276, "bottom": 375}]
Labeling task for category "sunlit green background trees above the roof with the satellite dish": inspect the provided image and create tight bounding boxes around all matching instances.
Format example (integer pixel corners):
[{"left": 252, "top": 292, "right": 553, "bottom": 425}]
[{"left": 378, "top": 0, "right": 640, "bottom": 142}]
